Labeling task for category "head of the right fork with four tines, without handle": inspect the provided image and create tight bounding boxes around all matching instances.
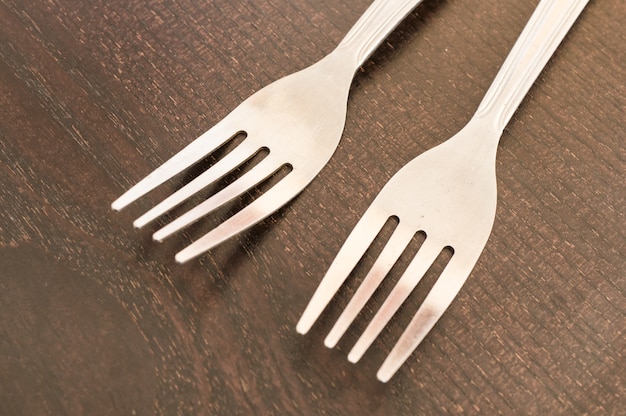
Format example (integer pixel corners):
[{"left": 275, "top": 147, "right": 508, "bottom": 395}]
[{"left": 296, "top": 116, "right": 499, "bottom": 382}]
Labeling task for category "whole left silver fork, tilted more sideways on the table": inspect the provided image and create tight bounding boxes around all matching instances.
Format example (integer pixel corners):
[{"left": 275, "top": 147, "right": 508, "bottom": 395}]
[{"left": 112, "top": 0, "right": 422, "bottom": 263}]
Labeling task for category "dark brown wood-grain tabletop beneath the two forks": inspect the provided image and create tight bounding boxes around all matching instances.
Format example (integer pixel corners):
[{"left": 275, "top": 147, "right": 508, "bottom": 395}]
[{"left": 0, "top": 0, "right": 626, "bottom": 415}]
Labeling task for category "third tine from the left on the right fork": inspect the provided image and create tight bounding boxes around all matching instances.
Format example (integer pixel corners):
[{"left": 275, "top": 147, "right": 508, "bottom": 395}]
[{"left": 348, "top": 237, "right": 442, "bottom": 363}]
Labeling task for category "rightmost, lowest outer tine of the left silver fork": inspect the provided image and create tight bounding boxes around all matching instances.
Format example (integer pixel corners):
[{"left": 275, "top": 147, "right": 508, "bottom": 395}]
[{"left": 176, "top": 170, "right": 307, "bottom": 263}]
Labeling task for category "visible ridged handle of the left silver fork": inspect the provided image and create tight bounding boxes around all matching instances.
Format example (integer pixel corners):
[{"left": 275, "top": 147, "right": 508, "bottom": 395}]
[{"left": 337, "top": 0, "right": 423, "bottom": 71}]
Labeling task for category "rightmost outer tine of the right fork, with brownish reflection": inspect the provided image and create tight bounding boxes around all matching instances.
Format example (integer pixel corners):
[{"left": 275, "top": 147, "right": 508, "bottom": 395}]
[{"left": 376, "top": 253, "right": 470, "bottom": 383}]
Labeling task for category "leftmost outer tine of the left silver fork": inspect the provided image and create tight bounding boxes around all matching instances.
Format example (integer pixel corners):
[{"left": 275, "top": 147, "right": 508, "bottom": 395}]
[{"left": 111, "top": 116, "right": 240, "bottom": 211}]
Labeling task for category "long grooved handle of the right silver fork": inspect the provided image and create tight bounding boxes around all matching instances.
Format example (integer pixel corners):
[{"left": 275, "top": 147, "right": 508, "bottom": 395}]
[{"left": 476, "top": 0, "right": 589, "bottom": 132}]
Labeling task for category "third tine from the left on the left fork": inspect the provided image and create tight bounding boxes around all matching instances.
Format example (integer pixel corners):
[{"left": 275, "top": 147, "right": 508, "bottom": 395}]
[{"left": 153, "top": 154, "right": 280, "bottom": 241}]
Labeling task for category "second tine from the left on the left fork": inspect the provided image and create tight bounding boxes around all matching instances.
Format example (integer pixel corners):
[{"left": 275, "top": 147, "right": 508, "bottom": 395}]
[{"left": 133, "top": 139, "right": 259, "bottom": 228}]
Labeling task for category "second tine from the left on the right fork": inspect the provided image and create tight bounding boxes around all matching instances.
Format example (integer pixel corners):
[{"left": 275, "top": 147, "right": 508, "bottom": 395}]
[{"left": 324, "top": 223, "right": 415, "bottom": 348}]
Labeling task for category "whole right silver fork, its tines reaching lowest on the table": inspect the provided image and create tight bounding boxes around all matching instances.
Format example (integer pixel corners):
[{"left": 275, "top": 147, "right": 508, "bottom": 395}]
[{"left": 296, "top": 0, "right": 588, "bottom": 382}]
